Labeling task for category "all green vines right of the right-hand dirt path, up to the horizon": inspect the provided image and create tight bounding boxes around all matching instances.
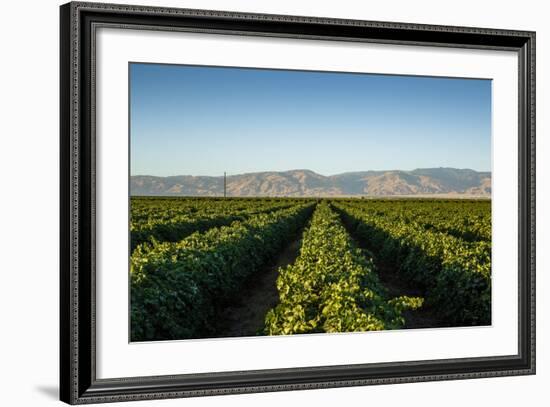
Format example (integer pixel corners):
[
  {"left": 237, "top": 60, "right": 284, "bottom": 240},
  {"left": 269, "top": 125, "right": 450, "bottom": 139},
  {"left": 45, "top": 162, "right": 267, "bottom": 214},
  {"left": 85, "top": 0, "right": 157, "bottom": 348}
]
[{"left": 334, "top": 201, "right": 491, "bottom": 325}]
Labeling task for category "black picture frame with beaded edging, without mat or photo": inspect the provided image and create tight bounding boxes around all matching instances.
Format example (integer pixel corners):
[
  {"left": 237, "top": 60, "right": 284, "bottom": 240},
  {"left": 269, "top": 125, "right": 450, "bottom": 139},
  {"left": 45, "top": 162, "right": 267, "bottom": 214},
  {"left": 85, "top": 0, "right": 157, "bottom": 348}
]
[{"left": 60, "top": 2, "right": 535, "bottom": 404}]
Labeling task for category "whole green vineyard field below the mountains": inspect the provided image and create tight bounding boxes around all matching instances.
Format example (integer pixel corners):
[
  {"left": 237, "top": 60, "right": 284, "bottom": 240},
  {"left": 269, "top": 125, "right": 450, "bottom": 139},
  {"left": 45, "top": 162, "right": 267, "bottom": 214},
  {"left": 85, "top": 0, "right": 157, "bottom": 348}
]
[{"left": 130, "top": 197, "right": 491, "bottom": 341}]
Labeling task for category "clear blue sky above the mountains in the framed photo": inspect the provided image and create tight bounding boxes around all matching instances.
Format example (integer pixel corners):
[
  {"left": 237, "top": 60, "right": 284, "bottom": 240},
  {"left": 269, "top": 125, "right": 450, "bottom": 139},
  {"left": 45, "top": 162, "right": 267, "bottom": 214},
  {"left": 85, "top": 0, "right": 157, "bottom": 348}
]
[{"left": 130, "top": 63, "right": 491, "bottom": 176}]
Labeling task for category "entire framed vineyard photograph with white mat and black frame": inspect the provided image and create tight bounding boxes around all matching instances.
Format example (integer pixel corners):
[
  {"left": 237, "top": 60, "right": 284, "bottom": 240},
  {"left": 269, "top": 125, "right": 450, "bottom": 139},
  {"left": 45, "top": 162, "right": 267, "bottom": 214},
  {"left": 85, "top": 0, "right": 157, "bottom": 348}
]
[{"left": 60, "top": 2, "right": 535, "bottom": 404}]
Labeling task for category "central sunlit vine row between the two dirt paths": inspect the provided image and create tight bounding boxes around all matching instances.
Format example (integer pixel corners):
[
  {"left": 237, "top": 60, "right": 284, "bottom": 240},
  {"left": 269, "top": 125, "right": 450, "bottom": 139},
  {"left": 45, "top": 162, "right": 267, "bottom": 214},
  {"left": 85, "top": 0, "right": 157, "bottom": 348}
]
[{"left": 265, "top": 202, "right": 423, "bottom": 335}]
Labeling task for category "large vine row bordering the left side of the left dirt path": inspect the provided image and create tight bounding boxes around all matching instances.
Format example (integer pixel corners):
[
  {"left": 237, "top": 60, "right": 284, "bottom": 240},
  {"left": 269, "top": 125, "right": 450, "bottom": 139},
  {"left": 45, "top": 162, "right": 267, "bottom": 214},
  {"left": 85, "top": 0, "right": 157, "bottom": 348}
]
[{"left": 130, "top": 203, "right": 313, "bottom": 341}]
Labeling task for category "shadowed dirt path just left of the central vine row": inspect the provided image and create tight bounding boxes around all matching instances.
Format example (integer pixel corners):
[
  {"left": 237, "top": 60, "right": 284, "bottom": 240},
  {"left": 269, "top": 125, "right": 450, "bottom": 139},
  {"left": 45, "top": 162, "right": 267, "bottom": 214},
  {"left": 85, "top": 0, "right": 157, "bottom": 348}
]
[{"left": 216, "top": 239, "right": 301, "bottom": 337}]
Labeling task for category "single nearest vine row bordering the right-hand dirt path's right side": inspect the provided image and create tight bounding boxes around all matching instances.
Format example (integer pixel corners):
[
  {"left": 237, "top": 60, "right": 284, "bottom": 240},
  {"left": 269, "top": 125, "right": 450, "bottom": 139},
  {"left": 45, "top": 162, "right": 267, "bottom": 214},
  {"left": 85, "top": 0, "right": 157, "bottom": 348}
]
[{"left": 334, "top": 202, "right": 491, "bottom": 325}]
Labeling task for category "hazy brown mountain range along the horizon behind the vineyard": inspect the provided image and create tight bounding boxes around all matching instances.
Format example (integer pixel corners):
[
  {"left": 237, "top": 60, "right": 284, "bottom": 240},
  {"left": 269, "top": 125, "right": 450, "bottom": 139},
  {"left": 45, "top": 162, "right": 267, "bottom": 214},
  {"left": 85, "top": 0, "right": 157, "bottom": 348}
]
[{"left": 130, "top": 168, "right": 491, "bottom": 197}]
